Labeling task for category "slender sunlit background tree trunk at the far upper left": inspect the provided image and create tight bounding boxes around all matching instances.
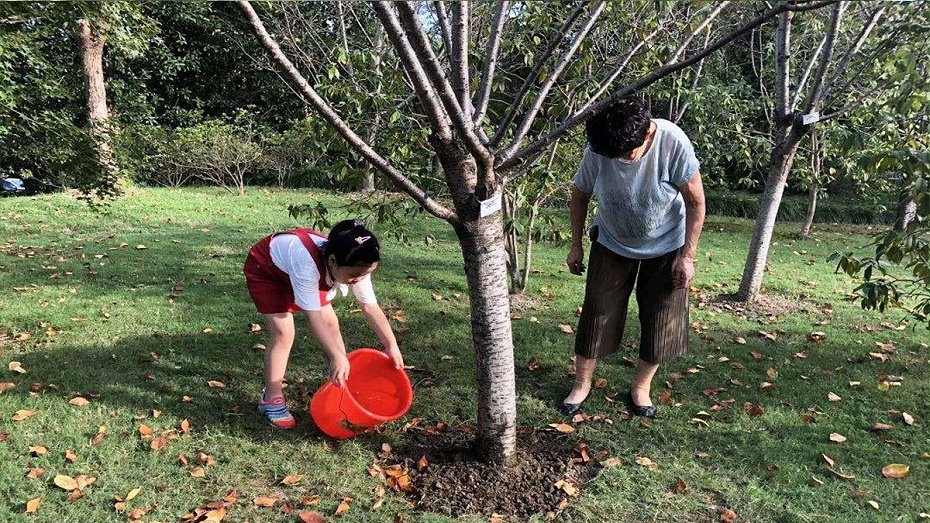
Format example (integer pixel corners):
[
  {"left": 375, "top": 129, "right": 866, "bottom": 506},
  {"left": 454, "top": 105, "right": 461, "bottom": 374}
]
[{"left": 77, "top": 19, "right": 116, "bottom": 176}]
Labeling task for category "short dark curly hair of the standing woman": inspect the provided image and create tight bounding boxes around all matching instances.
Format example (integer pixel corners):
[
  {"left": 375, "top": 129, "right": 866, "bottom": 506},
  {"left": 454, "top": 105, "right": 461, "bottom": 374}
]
[{"left": 585, "top": 96, "right": 652, "bottom": 158}]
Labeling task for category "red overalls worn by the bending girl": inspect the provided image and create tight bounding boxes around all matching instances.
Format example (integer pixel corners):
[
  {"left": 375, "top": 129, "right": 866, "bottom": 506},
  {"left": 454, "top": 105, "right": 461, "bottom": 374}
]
[{"left": 242, "top": 229, "right": 331, "bottom": 314}]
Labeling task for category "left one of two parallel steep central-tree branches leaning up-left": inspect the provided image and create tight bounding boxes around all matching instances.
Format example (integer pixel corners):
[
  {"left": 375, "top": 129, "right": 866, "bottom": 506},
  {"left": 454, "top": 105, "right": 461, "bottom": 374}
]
[{"left": 372, "top": 2, "right": 452, "bottom": 143}]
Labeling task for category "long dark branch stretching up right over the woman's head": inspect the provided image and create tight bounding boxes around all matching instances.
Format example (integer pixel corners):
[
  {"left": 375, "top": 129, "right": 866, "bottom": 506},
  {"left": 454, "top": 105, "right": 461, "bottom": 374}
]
[{"left": 496, "top": 0, "right": 837, "bottom": 170}]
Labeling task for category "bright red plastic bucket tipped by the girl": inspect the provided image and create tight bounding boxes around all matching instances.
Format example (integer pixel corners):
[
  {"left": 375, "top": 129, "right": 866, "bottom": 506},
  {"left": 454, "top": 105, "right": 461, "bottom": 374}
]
[{"left": 310, "top": 349, "right": 413, "bottom": 439}]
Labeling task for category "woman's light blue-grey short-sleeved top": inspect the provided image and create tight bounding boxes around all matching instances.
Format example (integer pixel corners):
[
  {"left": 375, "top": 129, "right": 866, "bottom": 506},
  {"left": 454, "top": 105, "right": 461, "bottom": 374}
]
[{"left": 575, "top": 118, "right": 700, "bottom": 260}]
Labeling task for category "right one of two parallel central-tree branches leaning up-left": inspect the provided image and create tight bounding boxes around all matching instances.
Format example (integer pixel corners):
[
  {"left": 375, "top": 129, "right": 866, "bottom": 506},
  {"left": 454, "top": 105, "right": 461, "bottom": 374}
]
[{"left": 392, "top": 2, "right": 494, "bottom": 183}]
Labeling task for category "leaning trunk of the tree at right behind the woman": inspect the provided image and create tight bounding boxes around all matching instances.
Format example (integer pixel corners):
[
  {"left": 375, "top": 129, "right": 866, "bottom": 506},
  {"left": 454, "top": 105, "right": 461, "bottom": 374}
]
[{"left": 737, "top": 125, "right": 803, "bottom": 301}]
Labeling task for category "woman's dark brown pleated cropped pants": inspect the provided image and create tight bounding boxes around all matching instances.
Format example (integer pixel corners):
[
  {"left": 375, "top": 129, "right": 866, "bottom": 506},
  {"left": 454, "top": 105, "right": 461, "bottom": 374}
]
[{"left": 575, "top": 232, "right": 688, "bottom": 363}]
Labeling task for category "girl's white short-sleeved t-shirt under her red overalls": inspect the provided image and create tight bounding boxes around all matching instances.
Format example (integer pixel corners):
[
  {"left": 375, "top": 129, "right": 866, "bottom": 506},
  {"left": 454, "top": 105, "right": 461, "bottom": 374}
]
[{"left": 269, "top": 234, "right": 378, "bottom": 311}]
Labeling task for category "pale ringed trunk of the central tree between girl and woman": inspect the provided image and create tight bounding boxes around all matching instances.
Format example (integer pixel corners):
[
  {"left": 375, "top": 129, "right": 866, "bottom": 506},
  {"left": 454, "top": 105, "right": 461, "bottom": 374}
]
[{"left": 434, "top": 140, "right": 517, "bottom": 463}]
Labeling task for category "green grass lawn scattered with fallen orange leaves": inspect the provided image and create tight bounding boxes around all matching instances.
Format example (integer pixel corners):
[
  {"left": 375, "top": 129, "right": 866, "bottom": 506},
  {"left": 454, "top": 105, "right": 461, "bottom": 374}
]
[{"left": 0, "top": 188, "right": 930, "bottom": 523}]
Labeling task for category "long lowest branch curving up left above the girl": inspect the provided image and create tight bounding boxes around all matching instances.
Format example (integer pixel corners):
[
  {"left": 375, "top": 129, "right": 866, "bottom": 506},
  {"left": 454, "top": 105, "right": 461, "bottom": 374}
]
[{"left": 238, "top": 0, "right": 458, "bottom": 225}]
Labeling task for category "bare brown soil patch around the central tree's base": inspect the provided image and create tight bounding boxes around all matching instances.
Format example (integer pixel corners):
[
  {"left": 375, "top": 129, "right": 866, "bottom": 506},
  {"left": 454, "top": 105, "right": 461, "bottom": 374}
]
[{"left": 384, "top": 429, "right": 600, "bottom": 519}]
